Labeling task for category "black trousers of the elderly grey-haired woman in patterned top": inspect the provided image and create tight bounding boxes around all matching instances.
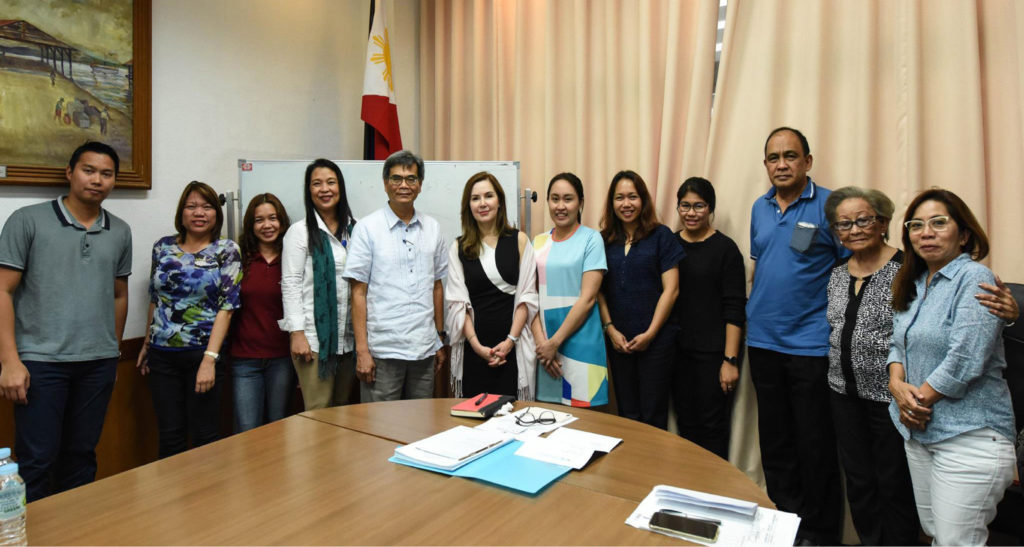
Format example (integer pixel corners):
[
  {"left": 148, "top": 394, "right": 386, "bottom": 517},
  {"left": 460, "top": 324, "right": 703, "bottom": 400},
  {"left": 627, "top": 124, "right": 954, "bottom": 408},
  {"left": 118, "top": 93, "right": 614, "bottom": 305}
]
[{"left": 828, "top": 389, "right": 920, "bottom": 545}]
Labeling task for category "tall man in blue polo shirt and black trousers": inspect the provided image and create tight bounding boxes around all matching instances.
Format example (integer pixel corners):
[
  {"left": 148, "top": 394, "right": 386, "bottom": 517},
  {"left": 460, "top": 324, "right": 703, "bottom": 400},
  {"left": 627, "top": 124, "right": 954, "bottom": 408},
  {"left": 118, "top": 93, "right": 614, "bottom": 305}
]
[{"left": 746, "top": 127, "right": 849, "bottom": 545}]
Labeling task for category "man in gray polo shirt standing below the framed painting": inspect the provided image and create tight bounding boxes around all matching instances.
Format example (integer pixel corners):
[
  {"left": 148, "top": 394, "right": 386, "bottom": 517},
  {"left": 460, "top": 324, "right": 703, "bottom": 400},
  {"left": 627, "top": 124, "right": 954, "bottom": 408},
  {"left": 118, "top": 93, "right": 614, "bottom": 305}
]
[{"left": 0, "top": 142, "right": 131, "bottom": 502}]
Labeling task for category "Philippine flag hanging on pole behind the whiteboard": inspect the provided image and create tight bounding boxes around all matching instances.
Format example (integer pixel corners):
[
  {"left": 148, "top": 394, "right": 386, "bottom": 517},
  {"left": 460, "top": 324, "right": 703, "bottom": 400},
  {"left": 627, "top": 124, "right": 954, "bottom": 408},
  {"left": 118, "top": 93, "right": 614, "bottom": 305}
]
[{"left": 359, "top": 0, "right": 401, "bottom": 160}]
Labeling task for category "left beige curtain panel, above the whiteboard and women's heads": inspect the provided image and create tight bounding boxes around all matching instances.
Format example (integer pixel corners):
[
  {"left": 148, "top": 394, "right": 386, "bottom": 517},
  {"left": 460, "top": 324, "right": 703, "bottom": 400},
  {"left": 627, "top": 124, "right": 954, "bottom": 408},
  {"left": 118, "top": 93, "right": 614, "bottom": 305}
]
[{"left": 420, "top": 0, "right": 718, "bottom": 229}]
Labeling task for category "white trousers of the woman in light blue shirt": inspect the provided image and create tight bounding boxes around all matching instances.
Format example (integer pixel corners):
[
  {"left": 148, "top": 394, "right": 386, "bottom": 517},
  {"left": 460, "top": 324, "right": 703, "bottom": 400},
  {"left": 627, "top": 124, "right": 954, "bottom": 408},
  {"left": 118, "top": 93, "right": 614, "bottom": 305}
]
[{"left": 904, "top": 427, "right": 1016, "bottom": 545}]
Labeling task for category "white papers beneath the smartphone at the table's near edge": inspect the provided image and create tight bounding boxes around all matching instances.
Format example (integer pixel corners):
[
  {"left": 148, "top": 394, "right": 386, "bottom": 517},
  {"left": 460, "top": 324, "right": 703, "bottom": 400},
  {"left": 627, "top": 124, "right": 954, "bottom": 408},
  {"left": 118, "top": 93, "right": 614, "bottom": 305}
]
[{"left": 626, "top": 485, "right": 800, "bottom": 545}]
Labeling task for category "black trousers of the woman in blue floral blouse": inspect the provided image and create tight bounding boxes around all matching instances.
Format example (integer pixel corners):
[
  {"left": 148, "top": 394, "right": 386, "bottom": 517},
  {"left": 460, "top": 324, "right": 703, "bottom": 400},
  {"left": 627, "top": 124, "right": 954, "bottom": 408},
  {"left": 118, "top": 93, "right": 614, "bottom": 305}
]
[{"left": 148, "top": 348, "right": 224, "bottom": 458}]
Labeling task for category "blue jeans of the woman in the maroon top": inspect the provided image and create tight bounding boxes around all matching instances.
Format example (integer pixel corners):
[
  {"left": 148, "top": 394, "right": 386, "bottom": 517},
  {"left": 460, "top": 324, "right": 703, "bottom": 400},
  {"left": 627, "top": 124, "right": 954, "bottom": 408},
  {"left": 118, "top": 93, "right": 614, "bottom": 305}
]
[{"left": 231, "top": 355, "right": 295, "bottom": 433}]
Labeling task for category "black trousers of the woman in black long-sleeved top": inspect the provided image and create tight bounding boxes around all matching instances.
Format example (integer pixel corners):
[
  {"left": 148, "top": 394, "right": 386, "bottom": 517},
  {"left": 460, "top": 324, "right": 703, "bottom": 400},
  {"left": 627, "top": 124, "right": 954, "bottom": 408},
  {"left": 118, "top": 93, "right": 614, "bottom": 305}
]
[{"left": 672, "top": 347, "right": 733, "bottom": 460}]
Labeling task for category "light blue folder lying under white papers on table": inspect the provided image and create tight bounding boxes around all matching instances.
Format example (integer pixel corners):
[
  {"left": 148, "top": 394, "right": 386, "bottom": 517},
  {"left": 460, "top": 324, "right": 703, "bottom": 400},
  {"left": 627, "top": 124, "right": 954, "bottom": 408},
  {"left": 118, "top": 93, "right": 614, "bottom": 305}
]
[{"left": 388, "top": 440, "right": 571, "bottom": 494}]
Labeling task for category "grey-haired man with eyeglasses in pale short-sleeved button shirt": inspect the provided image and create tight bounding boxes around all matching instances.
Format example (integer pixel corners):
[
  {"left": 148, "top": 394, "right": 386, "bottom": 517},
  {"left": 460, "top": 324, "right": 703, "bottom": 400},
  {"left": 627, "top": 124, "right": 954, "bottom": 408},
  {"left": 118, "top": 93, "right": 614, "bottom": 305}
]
[{"left": 344, "top": 151, "right": 447, "bottom": 403}]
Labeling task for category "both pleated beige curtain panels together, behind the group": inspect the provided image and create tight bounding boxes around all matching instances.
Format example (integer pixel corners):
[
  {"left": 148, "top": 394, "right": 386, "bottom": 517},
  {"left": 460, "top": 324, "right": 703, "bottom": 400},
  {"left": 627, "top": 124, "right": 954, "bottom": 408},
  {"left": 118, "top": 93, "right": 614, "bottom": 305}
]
[{"left": 420, "top": 0, "right": 1024, "bottom": 495}]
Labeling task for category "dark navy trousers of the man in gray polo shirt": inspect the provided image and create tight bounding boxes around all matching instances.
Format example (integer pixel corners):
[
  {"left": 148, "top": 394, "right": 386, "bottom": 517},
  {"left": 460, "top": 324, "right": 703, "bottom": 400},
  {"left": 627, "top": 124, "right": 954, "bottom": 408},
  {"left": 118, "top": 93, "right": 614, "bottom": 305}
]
[{"left": 14, "top": 357, "right": 118, "bottom": 502}]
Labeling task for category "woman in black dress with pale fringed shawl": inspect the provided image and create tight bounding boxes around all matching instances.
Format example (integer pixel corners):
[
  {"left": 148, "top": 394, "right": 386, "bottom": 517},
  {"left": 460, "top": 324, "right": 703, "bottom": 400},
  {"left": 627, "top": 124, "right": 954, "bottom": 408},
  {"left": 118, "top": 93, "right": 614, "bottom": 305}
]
[{"left": 444, "top": 172, "right": 538, "bottom": 401}]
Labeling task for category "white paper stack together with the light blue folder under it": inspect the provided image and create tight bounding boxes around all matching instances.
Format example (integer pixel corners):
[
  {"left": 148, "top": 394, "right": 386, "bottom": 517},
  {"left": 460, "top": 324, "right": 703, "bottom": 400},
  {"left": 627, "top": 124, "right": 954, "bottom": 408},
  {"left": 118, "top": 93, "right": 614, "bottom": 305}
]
[{"left": 388, "top": 425, "right": 569, "bottom": 494}]
